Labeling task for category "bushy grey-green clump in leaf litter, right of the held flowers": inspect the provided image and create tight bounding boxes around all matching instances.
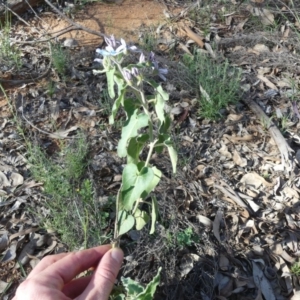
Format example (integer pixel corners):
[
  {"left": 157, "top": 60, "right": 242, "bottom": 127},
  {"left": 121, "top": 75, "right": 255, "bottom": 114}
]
[{"left": 183, "top": 53, "right": 241, "bottom": 120}]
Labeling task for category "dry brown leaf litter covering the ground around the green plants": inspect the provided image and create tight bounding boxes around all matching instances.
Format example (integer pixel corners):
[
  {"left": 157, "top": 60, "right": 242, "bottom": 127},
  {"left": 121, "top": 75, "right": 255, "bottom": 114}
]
[{"left": 0, "top": 0, "right": 300, "bottom": 300}]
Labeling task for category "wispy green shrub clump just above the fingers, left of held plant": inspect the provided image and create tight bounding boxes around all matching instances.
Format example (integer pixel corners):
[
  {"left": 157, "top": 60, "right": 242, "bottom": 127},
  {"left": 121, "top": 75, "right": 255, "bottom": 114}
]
[{"left": 28, "top": 134, "right": 109, "bottom": 249}]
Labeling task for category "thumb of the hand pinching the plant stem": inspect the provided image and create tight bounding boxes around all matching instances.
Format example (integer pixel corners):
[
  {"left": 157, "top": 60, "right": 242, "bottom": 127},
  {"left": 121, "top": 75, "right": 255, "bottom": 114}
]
[{"left": 78, "top": 248, "right": 124, "bottom": 300}]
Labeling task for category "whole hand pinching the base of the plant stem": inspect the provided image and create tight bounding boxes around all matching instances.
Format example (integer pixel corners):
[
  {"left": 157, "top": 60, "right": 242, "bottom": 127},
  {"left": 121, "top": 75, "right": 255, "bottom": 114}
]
[{"left": 13, "top": 245, "right": 123, "bottom": 300}]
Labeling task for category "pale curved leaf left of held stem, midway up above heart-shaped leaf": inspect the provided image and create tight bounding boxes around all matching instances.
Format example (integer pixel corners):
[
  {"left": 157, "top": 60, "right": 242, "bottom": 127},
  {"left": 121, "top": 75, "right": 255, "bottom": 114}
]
[{"left": 118, "top": 109, "right": 149, "bottom": 157}]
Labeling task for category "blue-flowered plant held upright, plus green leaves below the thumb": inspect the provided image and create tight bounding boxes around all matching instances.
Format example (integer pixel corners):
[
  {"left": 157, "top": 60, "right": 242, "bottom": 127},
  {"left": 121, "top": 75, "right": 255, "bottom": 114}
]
[{"left": 94, "top": 36, "right": 177, "bottom": 300}]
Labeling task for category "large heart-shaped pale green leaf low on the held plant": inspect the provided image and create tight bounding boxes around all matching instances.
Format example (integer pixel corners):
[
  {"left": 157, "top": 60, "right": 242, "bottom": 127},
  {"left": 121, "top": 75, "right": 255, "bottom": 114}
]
[{"left": 121, "top": 164, "right": 154, "bottom": 211}]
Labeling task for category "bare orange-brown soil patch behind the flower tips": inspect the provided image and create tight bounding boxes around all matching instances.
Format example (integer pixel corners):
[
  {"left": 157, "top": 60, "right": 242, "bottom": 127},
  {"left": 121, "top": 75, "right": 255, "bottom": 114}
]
[{"left": 42, "top": 0, "right": 165, "bottom": 46}]
